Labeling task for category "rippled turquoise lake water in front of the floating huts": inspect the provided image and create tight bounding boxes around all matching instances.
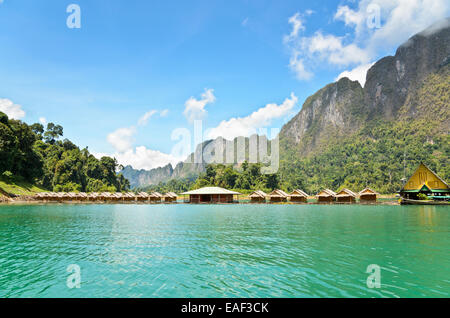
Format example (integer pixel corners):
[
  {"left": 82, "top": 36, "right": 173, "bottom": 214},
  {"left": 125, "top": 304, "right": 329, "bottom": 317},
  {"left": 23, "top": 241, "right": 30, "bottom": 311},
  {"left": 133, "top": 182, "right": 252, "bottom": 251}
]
[{"left": 0, "top": 204, "right": 450, "bottom": 297}]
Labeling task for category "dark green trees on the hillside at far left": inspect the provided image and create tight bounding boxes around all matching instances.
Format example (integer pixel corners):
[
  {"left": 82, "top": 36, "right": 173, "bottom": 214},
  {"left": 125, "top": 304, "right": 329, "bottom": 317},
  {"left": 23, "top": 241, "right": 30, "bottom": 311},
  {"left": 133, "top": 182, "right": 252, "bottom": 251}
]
[{"left": 0, "top": 112, "right": 130, "bottom": 192}]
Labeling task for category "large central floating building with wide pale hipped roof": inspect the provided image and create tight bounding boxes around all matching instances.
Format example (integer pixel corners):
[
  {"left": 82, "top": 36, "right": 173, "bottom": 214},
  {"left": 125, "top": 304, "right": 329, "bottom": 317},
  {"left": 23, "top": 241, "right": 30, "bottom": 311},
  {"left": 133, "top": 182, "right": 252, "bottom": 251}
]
[{"left": 182, "top": 187, "right": 240, "bottom": 203}]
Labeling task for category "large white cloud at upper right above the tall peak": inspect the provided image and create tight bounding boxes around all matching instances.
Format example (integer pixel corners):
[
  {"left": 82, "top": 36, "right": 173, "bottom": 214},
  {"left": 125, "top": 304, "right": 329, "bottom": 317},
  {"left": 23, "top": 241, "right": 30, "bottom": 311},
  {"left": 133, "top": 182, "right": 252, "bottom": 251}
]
[{"left": 283, "top": 0, "right": 450, "bottom": 80}]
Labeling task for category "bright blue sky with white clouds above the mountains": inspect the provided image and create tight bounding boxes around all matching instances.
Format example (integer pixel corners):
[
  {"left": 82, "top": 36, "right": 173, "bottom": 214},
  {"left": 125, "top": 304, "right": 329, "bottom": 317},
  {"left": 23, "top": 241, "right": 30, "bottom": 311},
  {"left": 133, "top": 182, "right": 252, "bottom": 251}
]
[{"left": 0, "top": 0, "right": 449, "bottom": 168}]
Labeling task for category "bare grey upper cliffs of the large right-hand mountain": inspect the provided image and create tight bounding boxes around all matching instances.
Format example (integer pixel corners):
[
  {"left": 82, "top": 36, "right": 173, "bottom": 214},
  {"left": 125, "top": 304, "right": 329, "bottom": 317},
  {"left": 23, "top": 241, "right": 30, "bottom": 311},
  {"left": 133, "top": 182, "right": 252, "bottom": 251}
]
[{"left": 280, "top": 18, "right": 450, "bottom": 155}]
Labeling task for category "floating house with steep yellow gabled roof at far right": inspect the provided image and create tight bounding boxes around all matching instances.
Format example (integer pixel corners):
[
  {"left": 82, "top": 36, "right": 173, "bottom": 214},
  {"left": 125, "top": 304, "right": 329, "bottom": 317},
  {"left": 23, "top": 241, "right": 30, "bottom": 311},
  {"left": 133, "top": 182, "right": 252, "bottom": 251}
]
[{"left": 400, "top": 163, "right": 450, "bottom": 200}]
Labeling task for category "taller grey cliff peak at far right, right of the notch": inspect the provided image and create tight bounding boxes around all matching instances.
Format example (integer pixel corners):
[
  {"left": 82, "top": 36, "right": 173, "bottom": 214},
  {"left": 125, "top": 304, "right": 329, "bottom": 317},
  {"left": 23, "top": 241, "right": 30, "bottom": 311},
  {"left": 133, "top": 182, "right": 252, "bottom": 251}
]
[{"left": 364, "top": 18, "right": 450, "bottom": 119}]
